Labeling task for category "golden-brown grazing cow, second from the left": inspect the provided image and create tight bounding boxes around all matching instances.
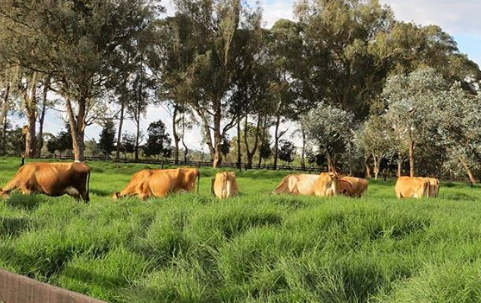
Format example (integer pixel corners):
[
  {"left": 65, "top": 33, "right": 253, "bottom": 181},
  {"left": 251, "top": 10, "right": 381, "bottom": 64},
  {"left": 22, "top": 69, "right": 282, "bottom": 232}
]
[{"left": 112, "top": 168, "right": 200, "bottom": 200}]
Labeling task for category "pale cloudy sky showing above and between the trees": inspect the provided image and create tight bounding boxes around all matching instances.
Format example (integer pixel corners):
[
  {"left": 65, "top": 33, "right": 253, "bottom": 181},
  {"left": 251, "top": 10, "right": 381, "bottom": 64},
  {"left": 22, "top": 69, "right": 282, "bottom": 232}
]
[{"left": 31, "top": 0, "right": 481, "bottom": 152}]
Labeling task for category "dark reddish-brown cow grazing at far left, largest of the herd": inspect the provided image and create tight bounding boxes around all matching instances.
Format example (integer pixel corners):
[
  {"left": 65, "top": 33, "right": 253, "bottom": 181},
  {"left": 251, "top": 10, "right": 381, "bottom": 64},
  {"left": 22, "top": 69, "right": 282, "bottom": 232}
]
[{"left": 0, "top": 162, "right": 90, "bottom": 202}]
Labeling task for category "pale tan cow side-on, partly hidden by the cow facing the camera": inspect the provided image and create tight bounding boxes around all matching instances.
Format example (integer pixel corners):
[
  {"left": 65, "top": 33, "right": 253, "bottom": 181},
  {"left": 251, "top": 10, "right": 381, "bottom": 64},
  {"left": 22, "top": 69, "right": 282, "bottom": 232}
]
[{"left": 272, "top": 174, "right": 319, "bottom": 195}]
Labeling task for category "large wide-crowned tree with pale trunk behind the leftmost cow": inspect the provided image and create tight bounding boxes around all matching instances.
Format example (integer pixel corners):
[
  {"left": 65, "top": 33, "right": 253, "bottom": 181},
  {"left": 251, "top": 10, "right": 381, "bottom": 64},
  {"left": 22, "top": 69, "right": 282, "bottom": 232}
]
[{"left": 0, "top": 0, "right": 160, "bottom": 161}]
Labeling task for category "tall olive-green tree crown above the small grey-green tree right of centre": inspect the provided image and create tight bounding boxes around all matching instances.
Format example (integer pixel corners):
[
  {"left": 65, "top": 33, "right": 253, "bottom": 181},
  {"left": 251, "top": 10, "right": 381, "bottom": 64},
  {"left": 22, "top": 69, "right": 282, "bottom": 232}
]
[{"left": 296, "top": 0, "right": 394, "bottom": 119}]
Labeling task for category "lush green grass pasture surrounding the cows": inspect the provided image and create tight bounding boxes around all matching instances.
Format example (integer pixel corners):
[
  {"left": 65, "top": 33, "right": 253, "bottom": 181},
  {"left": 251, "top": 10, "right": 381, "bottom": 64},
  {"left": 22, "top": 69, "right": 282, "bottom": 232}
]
[{"left": 0, "top": 158, "right": 481, "bottom": 303}]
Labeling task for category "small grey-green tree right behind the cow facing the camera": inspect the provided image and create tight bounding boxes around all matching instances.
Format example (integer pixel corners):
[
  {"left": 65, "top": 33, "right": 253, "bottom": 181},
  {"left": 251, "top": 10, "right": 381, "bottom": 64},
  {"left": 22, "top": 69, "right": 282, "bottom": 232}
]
[{"left": 301, "top": 102, "right": 354, "bottom": 172}]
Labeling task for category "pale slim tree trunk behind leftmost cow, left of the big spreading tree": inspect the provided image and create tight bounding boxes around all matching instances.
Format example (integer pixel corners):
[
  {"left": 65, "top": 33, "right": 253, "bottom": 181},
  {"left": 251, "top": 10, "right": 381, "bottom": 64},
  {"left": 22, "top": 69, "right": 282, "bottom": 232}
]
[{"left": 25, "top": 72, "right": 37, "bottom": 158}]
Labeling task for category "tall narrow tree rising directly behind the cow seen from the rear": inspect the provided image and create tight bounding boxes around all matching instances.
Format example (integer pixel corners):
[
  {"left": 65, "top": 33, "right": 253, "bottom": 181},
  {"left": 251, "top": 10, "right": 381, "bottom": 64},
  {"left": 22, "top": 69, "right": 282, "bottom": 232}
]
[{"left": 174, "top": 0, "right": 260, "bottom": 167}]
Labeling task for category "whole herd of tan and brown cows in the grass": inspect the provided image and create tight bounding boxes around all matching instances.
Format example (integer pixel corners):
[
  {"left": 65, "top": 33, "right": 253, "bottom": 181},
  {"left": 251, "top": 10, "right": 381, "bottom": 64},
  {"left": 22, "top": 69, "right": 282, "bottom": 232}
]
[{"left": 0, "top": 162, "right": 439, "bottom": 202}]
